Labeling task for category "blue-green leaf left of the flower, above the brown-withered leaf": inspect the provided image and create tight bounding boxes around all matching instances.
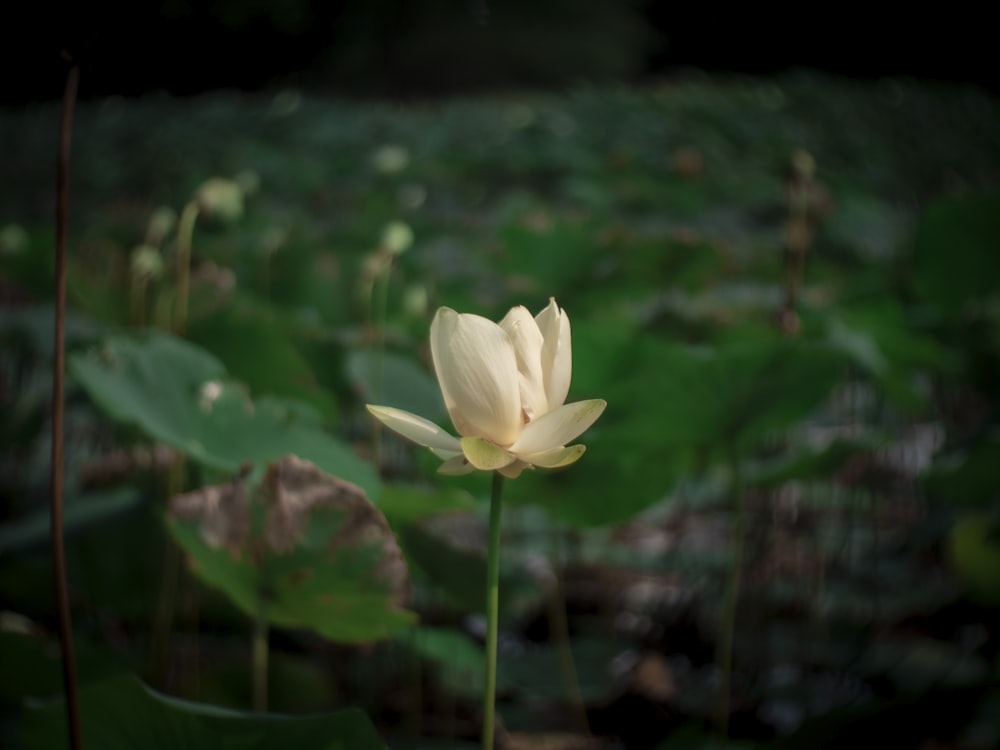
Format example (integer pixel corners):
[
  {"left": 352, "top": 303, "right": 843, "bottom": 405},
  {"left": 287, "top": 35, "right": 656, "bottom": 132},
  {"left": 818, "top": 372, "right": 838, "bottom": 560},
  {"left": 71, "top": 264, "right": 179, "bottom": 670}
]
[{"left": 69, "top": 332, "right": 379, "bottom": 497}]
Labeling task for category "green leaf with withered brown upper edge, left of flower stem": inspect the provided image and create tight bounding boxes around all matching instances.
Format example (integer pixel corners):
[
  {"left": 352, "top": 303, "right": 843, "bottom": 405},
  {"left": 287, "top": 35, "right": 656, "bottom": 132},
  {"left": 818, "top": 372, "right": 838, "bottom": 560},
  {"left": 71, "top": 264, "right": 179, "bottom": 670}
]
[{"left": 169, "top": 456, "right": 415, "bottom": 642}]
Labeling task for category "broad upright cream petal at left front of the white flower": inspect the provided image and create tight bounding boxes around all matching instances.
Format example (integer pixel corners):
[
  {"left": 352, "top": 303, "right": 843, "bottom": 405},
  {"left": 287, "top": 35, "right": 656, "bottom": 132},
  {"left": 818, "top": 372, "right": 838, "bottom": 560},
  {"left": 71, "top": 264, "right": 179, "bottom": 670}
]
[{"left": 431, "top": 307, "right": 523, "bottom": 445}]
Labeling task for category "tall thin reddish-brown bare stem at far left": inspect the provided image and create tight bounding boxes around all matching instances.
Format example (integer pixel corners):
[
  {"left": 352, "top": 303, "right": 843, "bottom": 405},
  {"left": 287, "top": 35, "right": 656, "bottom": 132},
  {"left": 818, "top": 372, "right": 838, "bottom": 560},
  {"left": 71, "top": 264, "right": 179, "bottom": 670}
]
[{"left": 51, "top": 58, "right": 83, "bottom": 750}]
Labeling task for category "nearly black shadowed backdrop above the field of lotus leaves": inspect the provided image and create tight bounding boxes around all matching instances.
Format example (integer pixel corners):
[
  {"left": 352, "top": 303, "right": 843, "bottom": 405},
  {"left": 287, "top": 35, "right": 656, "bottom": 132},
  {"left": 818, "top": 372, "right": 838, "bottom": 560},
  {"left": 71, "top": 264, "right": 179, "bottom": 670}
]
[{"left": 0, "top": 0, "right": 997, "bottom": 104}]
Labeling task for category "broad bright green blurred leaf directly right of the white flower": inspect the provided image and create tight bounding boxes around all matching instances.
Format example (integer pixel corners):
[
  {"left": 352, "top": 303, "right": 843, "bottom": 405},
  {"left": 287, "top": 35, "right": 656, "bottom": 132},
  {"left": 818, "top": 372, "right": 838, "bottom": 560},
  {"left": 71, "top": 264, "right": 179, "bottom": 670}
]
[{"left": 505, "top": 336, "right": 841, "bottom": 527}]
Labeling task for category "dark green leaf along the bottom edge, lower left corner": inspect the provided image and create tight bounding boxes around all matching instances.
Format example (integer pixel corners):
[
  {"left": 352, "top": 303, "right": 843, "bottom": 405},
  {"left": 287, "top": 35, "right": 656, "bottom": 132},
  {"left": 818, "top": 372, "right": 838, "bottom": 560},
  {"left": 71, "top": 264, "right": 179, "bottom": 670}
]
[{"left": 21, "top": 675, "right": 385, "bottom": 750}]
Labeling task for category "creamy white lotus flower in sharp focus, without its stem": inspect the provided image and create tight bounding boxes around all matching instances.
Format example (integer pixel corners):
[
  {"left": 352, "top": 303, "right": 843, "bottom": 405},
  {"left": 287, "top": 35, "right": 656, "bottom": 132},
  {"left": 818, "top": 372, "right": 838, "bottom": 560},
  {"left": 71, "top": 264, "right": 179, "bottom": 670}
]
[{"left": 368, "top": 299, "right": 607, "bottom": 478}]
